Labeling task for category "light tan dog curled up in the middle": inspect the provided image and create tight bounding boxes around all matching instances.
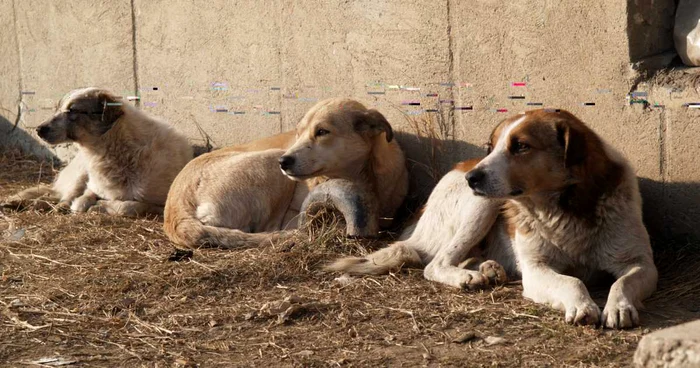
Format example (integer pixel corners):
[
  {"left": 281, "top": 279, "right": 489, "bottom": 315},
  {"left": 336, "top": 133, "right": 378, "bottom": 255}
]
[{"left": 164, "top": 99, "right": 408, "bottom": 248}]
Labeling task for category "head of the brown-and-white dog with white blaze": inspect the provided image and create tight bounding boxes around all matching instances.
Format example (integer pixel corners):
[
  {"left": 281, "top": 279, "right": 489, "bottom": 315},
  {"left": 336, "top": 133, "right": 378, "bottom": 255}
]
[{"left": 466, "top": 109, "right": 613, "bottom": 198}]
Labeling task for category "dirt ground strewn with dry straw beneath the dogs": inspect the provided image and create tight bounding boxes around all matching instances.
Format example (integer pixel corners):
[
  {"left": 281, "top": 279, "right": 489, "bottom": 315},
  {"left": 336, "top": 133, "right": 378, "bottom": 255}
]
[{"left": 0, "top": 154, "right": 700, "bottom": 367}]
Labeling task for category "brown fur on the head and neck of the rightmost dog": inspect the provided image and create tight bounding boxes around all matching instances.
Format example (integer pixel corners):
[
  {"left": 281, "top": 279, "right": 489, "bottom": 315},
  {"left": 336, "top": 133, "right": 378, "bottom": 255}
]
[{"left": 507, "top": 110, "right": 622, "bottom": 220}]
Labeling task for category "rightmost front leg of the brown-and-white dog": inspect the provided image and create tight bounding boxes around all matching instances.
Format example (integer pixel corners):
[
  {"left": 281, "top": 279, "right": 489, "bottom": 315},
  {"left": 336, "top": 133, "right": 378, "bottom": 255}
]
[{"left": 602, "top": 256, "right": 658, "bottom": 328}]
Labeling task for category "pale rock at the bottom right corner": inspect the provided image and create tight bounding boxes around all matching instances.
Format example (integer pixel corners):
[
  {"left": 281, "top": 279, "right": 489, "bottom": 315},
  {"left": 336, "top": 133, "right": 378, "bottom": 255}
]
[{"left": 634, "top": 320, "right": 700, "bottom": 368}]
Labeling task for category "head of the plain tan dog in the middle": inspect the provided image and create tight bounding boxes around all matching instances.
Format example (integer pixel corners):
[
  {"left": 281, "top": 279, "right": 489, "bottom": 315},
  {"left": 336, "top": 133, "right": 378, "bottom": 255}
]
[{"left": 280, "top": 98, "right": 394, "bottom": 180}]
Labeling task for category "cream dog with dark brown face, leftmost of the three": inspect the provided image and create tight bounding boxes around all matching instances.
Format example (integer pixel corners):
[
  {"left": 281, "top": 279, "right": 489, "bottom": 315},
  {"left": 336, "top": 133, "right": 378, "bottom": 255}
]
[{"left": 3, "top": 88, "right": 192, "bottom": 216}]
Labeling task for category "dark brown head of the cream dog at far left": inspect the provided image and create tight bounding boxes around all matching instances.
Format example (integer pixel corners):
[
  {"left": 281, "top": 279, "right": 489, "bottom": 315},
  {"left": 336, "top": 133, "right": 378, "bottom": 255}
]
[{"left": 36, "top": 88, "right": 124, "bottom": 144}]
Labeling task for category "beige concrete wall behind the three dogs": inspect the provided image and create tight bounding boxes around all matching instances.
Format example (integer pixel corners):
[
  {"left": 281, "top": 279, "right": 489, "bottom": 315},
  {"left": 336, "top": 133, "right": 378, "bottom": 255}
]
[{"left": 0, "top": 0, "right": 700, "bottom": 240}]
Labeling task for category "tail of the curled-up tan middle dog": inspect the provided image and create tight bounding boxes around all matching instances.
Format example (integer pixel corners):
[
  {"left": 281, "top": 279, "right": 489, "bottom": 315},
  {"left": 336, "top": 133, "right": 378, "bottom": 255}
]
[{"left": 164, "top": 218, "right": 290, "bottom": 249}]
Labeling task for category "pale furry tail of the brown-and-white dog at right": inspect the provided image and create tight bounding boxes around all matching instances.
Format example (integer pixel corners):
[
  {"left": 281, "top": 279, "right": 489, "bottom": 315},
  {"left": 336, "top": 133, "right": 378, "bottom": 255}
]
[{"left": 325, "top": 242, "right": 423, "bottom": 275}]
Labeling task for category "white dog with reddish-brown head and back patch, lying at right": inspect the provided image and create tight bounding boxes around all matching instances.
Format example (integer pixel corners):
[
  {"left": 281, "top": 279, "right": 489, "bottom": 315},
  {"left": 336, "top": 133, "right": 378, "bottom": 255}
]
[{"left": 328, "top": 110, "right": 657, "bottom": 328}]
